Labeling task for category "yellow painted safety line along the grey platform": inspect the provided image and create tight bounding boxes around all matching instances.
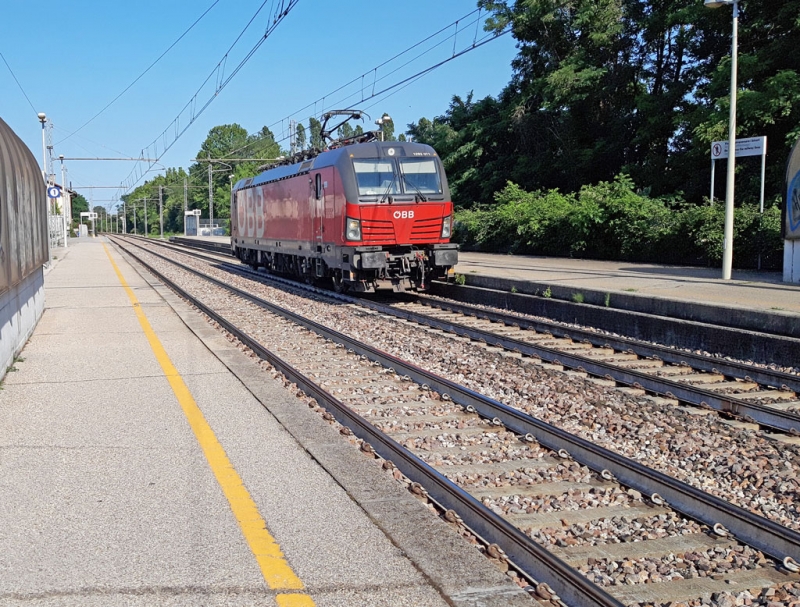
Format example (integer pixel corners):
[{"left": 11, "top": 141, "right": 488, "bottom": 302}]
[{"left": 103, "top": 244, "right": 314, "bottom": 607}]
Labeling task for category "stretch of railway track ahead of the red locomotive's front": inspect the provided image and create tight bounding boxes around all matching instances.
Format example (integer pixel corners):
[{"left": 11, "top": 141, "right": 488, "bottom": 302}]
[{"left": 156, "top": 236, "right": 800, "bottom": 438}]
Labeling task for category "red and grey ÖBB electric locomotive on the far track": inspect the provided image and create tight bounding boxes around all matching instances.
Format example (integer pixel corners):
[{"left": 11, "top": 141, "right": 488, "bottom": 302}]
[{"left": 231, "top": 115, "right": 458, "bottom": 292}]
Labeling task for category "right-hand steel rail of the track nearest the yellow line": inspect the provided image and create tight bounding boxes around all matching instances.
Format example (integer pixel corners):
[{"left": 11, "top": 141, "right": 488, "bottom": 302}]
[{"left": 111, "top": 235, "right": 800, "bottom": 568}]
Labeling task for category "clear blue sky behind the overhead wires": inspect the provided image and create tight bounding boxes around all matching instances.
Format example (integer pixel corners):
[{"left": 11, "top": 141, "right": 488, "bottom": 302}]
[{"left": 0, "top": 0, "right": 516, "bottom": 211}]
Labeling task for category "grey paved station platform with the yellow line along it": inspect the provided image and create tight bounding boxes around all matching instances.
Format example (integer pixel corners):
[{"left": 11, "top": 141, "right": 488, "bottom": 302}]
[{"left": 0, "top": 238, "right": 535, "bottom": 607}]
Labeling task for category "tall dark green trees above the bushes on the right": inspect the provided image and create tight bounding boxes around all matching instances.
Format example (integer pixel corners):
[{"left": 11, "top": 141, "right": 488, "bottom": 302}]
[{"left": 408, "top": 0, "right": 800, "bottom": 207}]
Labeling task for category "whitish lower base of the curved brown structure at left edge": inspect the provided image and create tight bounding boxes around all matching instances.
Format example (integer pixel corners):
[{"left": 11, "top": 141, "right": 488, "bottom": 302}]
[{"left": 0, "top": 267, "right": 44, "bottom": 379}]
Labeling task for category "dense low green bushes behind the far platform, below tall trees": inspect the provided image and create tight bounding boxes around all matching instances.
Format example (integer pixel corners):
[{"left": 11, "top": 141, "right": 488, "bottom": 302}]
[{"left": 454, "top": 175, "right": 783, "bottom": 269}]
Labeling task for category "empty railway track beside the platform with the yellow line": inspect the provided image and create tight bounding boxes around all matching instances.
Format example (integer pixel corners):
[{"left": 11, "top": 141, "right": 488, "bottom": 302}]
[{"left": 111, "top": 235, "right": 800, "bottom": 605}]
